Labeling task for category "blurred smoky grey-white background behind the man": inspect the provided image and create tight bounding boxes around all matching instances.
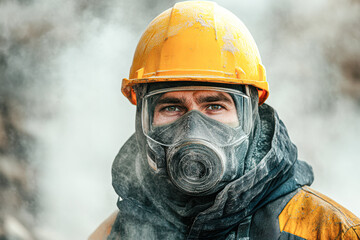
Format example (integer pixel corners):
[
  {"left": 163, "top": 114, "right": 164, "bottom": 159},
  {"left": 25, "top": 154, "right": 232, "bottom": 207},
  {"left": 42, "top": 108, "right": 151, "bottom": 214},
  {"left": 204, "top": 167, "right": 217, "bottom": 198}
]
[{"left": 0, "top": 0, "right": 360, "bottom": 240}]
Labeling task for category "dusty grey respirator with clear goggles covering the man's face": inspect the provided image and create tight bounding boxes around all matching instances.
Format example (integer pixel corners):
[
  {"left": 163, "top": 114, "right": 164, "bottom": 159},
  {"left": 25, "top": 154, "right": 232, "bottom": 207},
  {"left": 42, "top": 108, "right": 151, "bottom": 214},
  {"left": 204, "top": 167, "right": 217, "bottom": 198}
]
[{"left": 141, "top": 86, "right": 253, "bottom": 196}]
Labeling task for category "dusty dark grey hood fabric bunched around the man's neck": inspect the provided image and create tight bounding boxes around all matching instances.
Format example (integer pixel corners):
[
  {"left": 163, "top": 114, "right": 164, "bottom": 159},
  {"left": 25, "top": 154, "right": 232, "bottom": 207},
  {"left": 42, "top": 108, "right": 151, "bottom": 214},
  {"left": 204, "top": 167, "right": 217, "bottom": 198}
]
[{"left": 109, "top": 104, "right": 313, "bottom": 239}]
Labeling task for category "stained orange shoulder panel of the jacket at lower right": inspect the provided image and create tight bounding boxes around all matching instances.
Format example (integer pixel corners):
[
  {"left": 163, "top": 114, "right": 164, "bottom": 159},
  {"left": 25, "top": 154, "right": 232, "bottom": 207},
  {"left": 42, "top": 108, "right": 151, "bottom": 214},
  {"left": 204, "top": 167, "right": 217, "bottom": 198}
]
[{"left": 279, "top": 187, "right": 360, "bottom": 239}]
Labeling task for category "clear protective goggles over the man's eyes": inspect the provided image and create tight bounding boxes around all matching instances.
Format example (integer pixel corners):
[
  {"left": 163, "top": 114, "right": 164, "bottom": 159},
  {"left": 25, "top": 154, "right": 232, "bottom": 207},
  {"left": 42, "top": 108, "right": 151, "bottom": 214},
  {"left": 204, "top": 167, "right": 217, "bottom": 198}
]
[{"left": 142, "top": 86, "right": 252, "bottom": 146}]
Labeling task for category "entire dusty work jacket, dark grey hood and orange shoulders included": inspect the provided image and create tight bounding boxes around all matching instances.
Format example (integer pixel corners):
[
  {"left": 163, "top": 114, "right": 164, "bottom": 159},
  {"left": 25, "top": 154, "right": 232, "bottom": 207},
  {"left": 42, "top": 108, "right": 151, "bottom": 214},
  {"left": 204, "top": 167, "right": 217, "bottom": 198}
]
[{"left": 90, "top": 104, "right": 360, "bottom": 240}]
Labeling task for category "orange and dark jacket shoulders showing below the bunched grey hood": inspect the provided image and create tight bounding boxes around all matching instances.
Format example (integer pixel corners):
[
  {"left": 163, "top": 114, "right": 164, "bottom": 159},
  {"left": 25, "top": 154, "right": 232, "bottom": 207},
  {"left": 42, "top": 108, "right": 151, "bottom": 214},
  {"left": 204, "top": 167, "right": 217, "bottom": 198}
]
[{"left": 89, "top": 187, "right": 360, "bottom": 240}]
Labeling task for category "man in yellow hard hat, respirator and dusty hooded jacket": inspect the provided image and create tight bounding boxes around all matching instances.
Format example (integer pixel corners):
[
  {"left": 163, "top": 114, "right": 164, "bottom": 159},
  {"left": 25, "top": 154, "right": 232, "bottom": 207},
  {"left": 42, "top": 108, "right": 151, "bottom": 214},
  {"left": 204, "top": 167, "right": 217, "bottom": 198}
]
[{"left": 90, "top": 1, "right": 360, "bottom": 239}]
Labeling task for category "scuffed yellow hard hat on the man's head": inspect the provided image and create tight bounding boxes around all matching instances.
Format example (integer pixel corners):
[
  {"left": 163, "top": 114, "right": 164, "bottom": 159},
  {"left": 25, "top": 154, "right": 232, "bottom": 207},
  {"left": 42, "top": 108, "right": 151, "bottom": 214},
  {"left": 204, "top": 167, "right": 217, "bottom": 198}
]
[{"left": 121, "top": 1, "right": 269, "bottom": 104}]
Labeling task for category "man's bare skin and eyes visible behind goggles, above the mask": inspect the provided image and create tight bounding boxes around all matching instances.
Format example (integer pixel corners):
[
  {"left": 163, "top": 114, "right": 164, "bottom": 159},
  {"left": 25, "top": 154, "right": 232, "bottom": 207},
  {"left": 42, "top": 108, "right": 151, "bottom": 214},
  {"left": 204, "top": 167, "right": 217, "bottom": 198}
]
[{"left": 153, "top": 90, "right": 239, "bottom": 127}]
